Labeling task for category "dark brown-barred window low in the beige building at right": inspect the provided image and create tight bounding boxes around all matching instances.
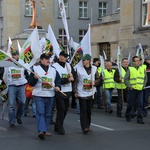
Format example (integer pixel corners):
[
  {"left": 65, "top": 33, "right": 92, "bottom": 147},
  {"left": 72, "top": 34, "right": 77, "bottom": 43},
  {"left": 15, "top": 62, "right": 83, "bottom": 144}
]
[{"left": 99, "top": 43, "right": 111, "bottom": 60}]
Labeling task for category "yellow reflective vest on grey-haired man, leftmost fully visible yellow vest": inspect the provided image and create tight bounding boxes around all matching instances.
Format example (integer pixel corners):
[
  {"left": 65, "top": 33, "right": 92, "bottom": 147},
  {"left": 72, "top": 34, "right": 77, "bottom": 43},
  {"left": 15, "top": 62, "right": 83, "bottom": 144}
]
[{"left": 103, "top": 69, "right": 115, "bottom": 89}]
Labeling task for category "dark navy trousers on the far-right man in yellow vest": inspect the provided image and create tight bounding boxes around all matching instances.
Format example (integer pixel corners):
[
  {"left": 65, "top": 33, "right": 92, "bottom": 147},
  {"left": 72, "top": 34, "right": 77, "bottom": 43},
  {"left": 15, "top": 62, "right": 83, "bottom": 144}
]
[{"left": 125, "top": 90, "right": 143, "bottom": 121}]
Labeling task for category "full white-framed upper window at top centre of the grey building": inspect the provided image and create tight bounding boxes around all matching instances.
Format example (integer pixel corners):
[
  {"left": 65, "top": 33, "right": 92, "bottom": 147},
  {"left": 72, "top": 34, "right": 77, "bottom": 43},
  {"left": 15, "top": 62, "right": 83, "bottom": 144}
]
[{"left": 79, "top": 2, "right": 88, "bottom": 19}]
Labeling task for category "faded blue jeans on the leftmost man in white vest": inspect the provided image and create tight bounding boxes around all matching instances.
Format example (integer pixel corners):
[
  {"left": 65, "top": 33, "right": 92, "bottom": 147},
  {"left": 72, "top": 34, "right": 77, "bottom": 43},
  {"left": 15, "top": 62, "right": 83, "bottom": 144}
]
[{"left": 8, "top": 85, "right": 26, "bottom": 124}]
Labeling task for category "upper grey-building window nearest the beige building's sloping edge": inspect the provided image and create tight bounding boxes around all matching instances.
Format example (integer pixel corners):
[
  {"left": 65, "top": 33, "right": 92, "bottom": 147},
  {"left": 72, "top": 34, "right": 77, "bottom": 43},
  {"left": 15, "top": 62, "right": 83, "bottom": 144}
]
[{"left": 98, "top": 2, "right": 107, "bottom": 19}]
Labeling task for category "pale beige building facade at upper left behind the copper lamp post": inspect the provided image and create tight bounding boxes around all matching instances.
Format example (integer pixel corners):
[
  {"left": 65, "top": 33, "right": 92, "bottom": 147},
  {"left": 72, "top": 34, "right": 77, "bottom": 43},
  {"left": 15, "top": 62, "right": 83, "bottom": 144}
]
[{"left": 0, "top": 0, "right": 53, "bottom": 50}]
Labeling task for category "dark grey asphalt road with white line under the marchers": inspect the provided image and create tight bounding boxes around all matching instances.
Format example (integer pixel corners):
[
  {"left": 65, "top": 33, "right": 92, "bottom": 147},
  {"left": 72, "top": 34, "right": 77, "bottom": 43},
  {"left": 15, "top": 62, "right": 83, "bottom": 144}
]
[{"left": 0, "top": 103, "right": 150, "bottom": 150}]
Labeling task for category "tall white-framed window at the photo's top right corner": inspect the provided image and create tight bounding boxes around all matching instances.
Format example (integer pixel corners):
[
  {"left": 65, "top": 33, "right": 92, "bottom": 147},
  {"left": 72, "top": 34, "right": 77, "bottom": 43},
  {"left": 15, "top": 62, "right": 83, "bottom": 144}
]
[{"left": 142, "top": 0, "right": 150, "bottom": 27}]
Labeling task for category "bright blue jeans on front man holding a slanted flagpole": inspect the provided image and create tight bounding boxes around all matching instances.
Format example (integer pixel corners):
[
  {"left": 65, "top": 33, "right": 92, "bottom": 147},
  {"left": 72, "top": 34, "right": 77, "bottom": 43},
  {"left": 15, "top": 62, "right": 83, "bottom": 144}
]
[{"left": 33, "top": 96, "right": 54, "bottom": 132}]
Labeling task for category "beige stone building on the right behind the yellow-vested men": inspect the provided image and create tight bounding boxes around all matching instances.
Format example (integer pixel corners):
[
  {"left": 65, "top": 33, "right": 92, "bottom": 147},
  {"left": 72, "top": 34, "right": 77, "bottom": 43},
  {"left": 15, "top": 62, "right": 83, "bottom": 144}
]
[{"left": 91, "top": 0, "right": 150, "bottom": 61}]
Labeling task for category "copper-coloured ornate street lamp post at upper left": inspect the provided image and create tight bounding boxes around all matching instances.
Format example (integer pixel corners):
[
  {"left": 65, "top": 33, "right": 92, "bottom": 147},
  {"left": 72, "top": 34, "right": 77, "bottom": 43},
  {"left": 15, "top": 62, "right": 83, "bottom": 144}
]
[{"left": 26, "top": 0, "right": 45, "bottom": 29}]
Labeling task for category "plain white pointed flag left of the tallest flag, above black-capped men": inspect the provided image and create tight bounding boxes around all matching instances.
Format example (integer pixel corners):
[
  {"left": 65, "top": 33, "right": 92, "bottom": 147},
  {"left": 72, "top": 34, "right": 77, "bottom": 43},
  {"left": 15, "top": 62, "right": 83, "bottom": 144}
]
[{"left": 46, "top": 24, "right": 61, "bottom": 62}]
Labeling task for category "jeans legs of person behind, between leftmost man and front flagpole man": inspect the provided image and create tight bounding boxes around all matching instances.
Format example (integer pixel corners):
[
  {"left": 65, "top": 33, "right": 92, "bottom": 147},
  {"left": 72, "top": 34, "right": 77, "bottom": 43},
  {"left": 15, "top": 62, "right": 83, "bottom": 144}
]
[{"left": 23, "top": 98, "right": 36, "bottom": 116}]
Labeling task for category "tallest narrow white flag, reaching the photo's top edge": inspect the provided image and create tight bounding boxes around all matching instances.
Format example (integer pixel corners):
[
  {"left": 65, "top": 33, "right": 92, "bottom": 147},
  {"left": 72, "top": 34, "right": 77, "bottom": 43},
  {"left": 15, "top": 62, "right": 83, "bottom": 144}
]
[{"left": 58, "top": 0, "right": 70, "bottom": 43}]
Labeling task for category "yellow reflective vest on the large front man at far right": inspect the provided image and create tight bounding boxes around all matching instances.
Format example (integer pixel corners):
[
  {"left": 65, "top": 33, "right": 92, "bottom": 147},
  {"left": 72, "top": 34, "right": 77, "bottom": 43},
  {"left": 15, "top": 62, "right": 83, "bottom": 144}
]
[{"left": 129, "top": 66, "right": 145, "bottom": 90}]
